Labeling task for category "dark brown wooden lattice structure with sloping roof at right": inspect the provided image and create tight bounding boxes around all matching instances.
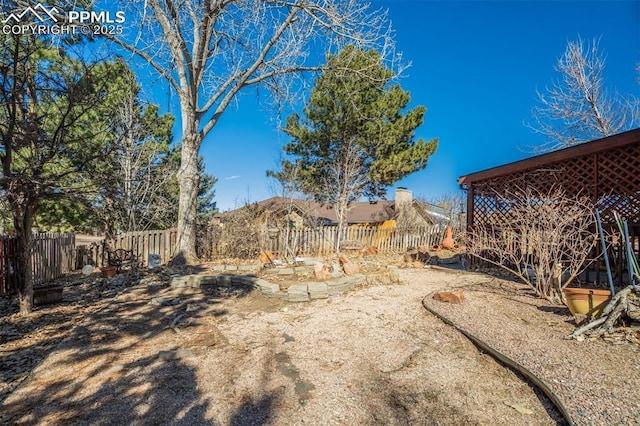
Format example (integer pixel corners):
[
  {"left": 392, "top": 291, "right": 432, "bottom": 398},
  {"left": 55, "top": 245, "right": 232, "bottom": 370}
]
[{"left": 458, "top": 129, "right": 640, "bottom": 282}]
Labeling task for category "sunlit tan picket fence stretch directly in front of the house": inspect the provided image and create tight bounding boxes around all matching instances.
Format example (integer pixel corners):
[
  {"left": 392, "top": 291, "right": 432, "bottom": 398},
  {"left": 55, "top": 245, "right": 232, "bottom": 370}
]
[{"left": 264, "top": 225, "right": 444, "bottom": 256}]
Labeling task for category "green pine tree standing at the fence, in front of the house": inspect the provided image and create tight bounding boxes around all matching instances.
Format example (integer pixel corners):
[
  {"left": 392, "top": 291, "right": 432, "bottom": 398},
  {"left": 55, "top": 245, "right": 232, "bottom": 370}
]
[{"left": 268, "top": 46, "right": 438, "bottom": 248}]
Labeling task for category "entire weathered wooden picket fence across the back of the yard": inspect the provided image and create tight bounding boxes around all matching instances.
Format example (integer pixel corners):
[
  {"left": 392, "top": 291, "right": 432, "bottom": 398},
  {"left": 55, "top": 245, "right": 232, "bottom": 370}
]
[{"left": 0, "top": 225, "right": 444, "bottom": 295}]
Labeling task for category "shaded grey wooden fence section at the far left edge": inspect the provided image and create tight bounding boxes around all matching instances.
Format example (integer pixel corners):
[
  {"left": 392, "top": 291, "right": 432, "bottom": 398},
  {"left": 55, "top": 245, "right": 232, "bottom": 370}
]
[{"left": 0, "top": 234, "right": 75, "bottom": 295}]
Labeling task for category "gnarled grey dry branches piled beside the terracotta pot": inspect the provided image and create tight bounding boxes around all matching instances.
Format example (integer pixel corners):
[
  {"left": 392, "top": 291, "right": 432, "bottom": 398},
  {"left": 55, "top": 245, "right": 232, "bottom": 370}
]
[{"left": 569, "top": 286, "right": 640, "bottom": 343}]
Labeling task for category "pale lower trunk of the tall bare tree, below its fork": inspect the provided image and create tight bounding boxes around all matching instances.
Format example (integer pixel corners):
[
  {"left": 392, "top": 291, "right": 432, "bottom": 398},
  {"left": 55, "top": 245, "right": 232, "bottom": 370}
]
[{"left": 174, "top": 120, "right": 201, "bottom": 263}]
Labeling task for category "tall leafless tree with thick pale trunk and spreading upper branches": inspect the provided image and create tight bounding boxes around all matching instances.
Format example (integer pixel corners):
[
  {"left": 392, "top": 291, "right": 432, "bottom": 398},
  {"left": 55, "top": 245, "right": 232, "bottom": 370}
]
[{"left": 106, "top": 0, "right": 393, "bottom": 260}]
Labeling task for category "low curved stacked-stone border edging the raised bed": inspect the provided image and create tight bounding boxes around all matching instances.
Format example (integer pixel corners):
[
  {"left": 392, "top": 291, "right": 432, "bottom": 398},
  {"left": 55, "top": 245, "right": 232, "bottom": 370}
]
[{"left": 170, "top": 268, "right": 399, "bottom": 302}]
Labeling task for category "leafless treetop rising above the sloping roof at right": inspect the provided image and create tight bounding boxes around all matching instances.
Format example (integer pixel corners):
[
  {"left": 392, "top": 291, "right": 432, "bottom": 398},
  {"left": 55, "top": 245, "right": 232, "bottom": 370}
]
[{"left": 528, "top": 38, "right": 640, "bottom": 152}]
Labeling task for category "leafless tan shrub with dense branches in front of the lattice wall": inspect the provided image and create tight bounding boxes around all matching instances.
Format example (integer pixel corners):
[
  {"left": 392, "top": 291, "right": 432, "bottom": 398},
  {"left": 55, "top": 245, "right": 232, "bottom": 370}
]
[{"left": 467, "top": 189, "right": 597, "bottom": 303}]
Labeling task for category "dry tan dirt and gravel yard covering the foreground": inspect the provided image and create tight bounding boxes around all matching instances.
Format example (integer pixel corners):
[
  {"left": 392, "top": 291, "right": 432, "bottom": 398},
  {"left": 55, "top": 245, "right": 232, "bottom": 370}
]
[{"left": 0, "top": 269, "right": 640, "bottom": 425}]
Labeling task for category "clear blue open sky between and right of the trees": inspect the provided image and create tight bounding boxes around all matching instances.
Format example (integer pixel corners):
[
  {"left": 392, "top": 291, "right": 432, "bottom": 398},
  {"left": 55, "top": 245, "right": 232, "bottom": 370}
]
[{"left": 195, "top": 0, "right": 640, "bottom": 210}]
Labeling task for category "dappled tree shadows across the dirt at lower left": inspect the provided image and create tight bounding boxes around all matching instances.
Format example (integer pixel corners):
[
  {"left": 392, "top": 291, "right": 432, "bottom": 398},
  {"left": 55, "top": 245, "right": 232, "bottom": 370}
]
[{"left": 0, "top": 271, "right": 260, "bottom": 424}]
